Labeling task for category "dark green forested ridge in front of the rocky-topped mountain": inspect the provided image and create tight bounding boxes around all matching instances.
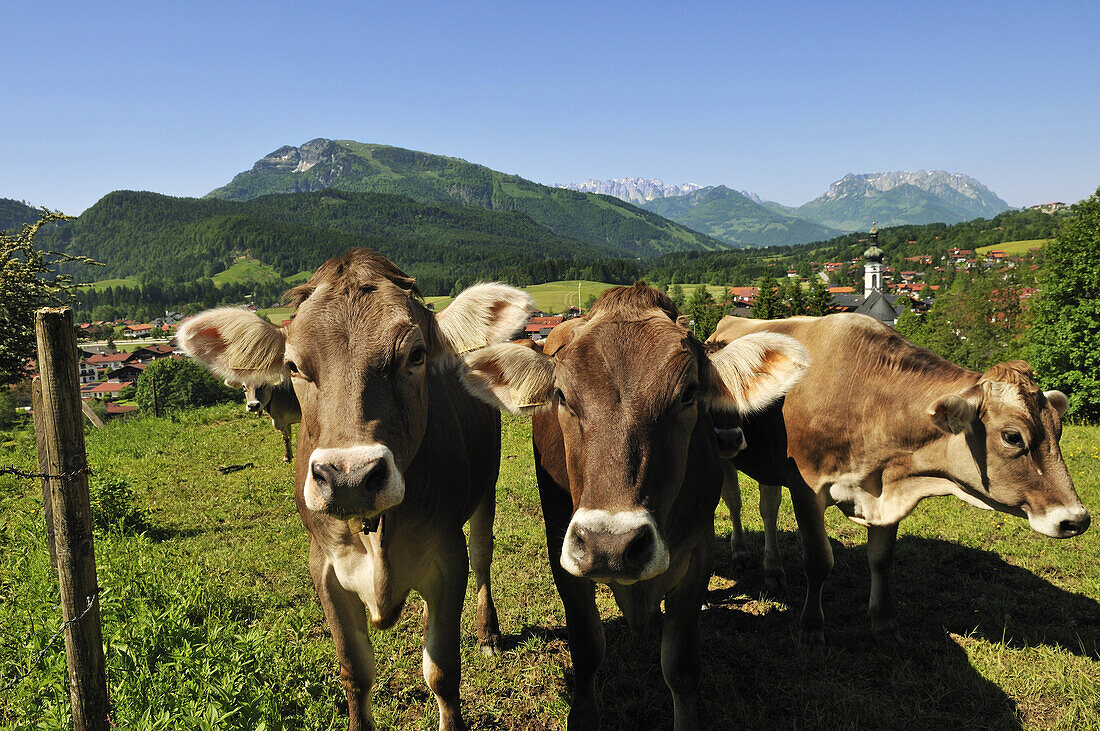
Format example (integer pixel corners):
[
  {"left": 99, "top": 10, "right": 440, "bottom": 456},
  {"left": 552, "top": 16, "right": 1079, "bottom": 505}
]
[{"left": 40, "top": 190, "right": 638, "bottom": 293}]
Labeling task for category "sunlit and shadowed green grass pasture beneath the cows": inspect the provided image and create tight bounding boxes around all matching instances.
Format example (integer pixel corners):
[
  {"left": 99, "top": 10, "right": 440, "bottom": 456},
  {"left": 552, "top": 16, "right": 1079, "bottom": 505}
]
[{"left": 0, "top": 406, "right": 1100, "bottom": 730}]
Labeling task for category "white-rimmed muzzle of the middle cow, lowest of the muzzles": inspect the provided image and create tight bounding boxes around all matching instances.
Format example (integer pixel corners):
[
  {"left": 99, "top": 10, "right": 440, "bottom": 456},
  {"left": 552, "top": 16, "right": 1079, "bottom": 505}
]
[{"left": 561, "top": 508, "right": 669, "bottom": 584}]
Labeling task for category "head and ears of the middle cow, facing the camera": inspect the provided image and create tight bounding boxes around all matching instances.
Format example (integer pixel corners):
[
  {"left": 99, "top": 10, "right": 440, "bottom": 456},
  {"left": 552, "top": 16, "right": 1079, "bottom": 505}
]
[{"left": 466, "top": 283, "right": 806, "bottom": 583}]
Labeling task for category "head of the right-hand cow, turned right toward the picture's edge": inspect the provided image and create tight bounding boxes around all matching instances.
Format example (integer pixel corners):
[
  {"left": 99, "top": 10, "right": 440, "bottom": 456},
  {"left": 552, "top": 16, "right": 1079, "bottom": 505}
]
[{"left": 928, "top": 361, "right": 1089, "bottom": 538}]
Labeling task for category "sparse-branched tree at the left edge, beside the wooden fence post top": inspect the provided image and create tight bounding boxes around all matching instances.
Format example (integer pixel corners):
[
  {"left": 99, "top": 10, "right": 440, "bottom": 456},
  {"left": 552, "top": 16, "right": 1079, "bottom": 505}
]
[{"left": 0, "top": 209, "right": 95, "bottom": 385}]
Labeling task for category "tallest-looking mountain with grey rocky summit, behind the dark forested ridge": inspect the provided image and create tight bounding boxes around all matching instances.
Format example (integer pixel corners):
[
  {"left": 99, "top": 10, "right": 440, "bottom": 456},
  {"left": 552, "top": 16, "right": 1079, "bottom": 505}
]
[{"left": 207, "top": 140, "right": 726, "bottom": 257}]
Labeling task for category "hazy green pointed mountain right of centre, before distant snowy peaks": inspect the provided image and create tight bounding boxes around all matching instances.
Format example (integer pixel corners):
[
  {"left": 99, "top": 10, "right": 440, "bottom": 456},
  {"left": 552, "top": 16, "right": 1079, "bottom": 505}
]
[{"left": 645, "top": 186, "right": 840, "bottom": 246}]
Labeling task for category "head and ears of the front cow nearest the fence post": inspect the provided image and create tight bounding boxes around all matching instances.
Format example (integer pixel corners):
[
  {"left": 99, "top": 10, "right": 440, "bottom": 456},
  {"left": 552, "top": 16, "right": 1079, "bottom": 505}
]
[{"left": 179, "top": 250, "right": 532, "bottom": 519}]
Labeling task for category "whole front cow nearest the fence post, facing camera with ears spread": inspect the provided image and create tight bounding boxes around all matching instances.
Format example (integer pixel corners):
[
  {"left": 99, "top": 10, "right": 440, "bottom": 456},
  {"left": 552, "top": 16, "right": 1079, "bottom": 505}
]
[{"left": 179, "top": 250, "right": 532, "bottom": 730}]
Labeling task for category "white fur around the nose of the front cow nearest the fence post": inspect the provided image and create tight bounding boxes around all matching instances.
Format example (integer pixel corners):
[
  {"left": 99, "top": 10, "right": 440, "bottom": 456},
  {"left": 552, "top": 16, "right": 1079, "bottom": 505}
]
[{"left": 304, "top": 444, "right": 405, "bottom": 518}]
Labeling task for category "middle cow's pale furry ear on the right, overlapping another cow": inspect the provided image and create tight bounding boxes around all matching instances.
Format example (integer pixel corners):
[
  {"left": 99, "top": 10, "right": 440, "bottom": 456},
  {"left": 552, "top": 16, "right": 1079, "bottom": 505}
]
[{"left": 705, "top": 333, "right": 810, "bottom": 413}]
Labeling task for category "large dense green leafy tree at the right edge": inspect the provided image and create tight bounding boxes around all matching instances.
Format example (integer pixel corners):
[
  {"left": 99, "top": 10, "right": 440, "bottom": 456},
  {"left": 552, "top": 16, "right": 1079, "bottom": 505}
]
[{"left": 1030, "top": 189, "right": 1100, "bottom": 421}]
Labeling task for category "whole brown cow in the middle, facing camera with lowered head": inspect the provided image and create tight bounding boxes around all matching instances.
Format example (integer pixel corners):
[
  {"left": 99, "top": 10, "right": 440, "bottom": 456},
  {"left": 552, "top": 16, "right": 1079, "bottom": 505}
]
[{"left": 466, "top": 283, "right": 805, "bottom": 729}]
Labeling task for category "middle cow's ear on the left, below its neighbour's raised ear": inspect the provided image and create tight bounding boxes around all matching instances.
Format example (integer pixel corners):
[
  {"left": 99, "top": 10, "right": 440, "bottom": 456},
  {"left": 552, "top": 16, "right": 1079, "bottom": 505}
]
[{"left": 463, "top": 343, "right": 553, "bottom": 414}]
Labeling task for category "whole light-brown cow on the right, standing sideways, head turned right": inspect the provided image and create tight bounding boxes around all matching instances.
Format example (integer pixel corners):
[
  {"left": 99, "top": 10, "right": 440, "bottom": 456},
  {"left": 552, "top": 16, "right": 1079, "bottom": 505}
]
[{"left": 711, "top": 314, "right": 1089, "bottom": 644}]
